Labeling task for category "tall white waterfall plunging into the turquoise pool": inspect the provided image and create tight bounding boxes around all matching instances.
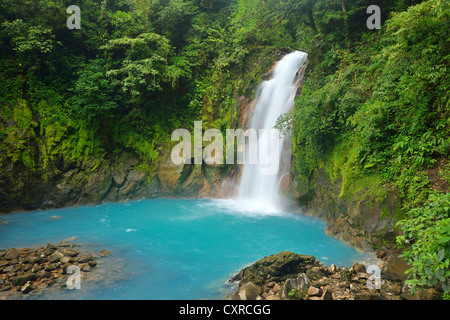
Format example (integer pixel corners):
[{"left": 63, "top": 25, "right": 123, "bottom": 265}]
[{"left": 239, "top": 51, "right": 307, "bottom": 212}]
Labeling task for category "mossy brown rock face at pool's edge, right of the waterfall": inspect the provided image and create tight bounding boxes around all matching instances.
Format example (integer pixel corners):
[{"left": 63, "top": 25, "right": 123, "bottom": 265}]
[{"left": 291, "top": 167, "right": 399, "bottom": 251}]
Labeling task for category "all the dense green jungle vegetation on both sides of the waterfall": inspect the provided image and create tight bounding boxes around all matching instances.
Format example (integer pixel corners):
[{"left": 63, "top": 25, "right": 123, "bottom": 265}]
[{"left": 0, "top": 0, "right": 450, "bottom": 293}]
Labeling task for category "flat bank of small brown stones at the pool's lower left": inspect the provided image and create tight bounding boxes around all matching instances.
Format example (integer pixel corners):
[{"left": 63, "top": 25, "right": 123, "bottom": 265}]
[{"left": 0, "top": 241, "right": 111, "bottom": 300}]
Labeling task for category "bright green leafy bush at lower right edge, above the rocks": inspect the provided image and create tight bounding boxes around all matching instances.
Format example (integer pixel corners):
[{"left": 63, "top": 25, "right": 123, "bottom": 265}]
[{"left": 397, "top": 193, "right": 450, "bottom": 294}]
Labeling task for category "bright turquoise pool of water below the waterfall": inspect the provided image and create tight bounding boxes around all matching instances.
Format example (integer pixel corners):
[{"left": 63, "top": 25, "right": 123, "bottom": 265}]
[{"left": 0, "top": 199, "right": 367, "bottom": 300}]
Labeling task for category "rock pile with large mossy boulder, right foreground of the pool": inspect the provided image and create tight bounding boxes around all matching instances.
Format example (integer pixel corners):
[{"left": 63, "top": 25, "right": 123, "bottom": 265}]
[{"left": 226, "top": 251, "right": 442, "bottom": 300}]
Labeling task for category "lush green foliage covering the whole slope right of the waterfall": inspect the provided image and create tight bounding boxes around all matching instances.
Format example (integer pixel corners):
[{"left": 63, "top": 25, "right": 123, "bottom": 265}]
[{"left": 286, "top": 0, "right": 450, "bottom": 292}]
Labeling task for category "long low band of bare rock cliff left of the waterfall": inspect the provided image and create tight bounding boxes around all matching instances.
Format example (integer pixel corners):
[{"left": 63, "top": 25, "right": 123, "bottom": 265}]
[{"left": 0, "top": 146, "right": 243, "bottom": 213}]
